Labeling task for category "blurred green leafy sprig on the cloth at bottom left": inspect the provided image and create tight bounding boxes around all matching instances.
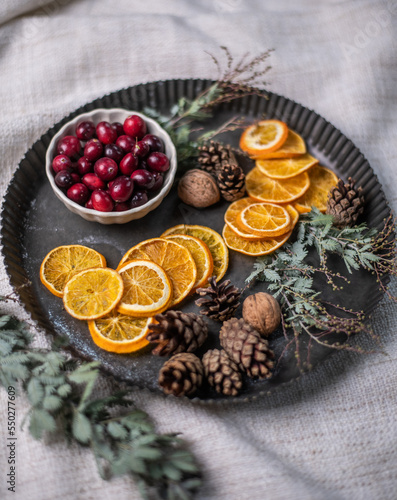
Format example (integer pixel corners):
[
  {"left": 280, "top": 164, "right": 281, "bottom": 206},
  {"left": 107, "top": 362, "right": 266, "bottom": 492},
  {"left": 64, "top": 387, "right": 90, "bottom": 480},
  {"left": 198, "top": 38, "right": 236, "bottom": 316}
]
[{"left": 0, "top": 315, "right": 201, "bottom": 500}]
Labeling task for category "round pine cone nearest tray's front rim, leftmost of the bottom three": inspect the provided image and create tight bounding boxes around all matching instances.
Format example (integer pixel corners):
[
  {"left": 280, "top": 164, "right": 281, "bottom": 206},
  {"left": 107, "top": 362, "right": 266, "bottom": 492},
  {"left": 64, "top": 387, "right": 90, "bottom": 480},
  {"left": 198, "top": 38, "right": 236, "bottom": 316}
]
[{"left": 159, "top": 352, "right": 204, "bottom": 396}]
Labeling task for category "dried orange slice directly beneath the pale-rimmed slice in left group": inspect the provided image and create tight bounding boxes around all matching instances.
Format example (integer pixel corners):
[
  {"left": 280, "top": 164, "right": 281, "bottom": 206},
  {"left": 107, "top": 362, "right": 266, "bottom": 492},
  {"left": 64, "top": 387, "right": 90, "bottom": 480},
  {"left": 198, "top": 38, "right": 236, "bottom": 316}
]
[{"left": 117, "top": 238, "right": 197, "bottom": 307}]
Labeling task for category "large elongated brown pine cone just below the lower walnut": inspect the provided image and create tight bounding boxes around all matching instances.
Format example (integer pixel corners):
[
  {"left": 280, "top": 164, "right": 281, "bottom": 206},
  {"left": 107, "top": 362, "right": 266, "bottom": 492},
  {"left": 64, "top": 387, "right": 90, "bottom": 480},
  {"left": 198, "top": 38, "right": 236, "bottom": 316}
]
[{"left": 220, "top": 318, "right": 274, "bottom": 378}]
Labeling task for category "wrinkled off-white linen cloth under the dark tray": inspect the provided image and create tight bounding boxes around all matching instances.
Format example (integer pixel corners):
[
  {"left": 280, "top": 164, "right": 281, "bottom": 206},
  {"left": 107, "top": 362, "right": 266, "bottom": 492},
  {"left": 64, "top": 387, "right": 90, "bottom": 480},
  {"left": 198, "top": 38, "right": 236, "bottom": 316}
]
[{"left": 0, "top": 0, "right": 397, "bottom": 500}]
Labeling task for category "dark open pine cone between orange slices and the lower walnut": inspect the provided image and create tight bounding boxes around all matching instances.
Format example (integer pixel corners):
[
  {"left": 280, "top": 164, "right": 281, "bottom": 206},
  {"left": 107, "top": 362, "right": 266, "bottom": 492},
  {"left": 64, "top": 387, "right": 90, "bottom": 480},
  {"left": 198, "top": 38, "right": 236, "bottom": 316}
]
[{"left": 196, "top": 276, "right": 241, "bottom": 321}]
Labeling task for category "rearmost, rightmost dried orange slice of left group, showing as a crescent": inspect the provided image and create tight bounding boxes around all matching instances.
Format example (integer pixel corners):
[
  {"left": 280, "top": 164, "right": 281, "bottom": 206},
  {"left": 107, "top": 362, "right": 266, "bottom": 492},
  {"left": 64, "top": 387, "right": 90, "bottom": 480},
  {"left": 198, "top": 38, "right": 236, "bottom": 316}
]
[{"left": 161, "top": 224, "right": 229, "bottom": 281}]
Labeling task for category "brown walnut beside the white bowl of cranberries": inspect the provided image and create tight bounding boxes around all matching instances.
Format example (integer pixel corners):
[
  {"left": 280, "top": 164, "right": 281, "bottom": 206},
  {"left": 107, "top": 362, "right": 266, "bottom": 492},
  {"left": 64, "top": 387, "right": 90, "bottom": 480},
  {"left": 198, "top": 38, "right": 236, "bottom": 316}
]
[{"left": 178, "top": 168, "right": 220, "bottom": 208}]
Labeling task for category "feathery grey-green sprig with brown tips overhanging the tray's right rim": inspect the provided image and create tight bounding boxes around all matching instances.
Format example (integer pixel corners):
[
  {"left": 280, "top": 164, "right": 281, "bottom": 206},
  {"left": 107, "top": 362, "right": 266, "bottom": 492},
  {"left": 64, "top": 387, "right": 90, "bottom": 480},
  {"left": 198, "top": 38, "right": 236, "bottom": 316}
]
[{"left": 247, "top": 208, "right": 396, "bottom": 368}]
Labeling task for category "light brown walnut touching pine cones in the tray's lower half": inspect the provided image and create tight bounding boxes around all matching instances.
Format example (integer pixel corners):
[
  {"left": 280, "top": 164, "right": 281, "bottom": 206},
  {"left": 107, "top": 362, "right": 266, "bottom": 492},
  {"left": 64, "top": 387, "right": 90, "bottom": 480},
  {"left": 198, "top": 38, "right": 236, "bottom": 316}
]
[{"left": 243, "top": 292, "right": 281, "bottom": 337}]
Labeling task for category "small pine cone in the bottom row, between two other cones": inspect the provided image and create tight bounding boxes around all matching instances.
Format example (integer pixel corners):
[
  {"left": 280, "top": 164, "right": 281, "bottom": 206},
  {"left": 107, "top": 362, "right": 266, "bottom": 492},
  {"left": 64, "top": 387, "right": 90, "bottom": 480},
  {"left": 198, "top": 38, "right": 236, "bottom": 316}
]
[{"left": 203, "top": 349, "right": 243, "bottom": 396}]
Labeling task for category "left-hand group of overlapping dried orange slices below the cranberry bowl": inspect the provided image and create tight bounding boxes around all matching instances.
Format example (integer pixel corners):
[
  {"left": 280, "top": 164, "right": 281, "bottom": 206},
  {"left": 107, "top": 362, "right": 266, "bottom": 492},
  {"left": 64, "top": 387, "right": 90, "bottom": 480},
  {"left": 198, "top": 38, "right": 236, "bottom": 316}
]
[{"left": 40, "top": 225, "right": 228, "bottom": 353}]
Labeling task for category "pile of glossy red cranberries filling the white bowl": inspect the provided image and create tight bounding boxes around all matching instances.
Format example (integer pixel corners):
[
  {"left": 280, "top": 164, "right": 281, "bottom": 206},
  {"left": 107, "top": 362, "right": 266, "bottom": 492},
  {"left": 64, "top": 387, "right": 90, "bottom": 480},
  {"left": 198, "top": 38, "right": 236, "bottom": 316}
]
[{"left": 52, "top": 115, "right": 170, "bottom": 212}]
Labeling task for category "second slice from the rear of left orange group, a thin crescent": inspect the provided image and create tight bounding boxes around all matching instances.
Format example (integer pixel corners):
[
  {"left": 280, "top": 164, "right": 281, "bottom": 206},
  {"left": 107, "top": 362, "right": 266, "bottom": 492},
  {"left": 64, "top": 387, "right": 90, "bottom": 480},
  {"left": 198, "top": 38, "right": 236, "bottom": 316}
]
[{"left": 165, "top": 234, "right": 214, "bottom": 292}]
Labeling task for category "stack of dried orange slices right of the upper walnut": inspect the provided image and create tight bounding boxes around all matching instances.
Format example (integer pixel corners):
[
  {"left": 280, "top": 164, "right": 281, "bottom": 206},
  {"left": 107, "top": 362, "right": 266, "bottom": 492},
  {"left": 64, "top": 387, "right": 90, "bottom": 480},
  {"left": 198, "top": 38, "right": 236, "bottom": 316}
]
[{"left": 223, "top": 120, "right": 338, "bottom": 256}]
